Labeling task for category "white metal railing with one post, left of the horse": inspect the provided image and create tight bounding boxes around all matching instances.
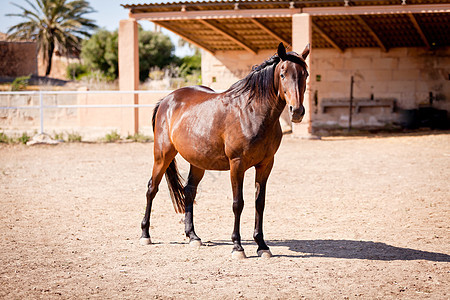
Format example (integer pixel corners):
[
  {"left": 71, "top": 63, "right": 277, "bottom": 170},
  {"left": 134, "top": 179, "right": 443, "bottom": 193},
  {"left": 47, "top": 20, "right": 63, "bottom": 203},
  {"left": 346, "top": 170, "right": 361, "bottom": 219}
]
[{"left": 0, "top": 90, "right": 173, "bottom": 133}]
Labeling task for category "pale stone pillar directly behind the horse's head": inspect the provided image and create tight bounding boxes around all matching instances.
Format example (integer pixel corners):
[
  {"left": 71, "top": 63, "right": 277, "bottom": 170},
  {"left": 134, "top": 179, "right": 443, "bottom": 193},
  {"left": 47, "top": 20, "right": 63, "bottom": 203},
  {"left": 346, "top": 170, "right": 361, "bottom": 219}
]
[{"left": 292, "top": 13, "right": 314, "bottom": 138}]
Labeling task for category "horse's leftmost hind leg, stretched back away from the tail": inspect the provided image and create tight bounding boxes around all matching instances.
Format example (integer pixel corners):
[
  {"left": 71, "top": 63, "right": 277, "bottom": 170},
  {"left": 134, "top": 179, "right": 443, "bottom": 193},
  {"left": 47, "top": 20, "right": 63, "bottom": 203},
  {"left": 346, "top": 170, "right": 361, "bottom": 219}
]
[{"left": 140, "top": 147, "right": 177, "bottom": 245}]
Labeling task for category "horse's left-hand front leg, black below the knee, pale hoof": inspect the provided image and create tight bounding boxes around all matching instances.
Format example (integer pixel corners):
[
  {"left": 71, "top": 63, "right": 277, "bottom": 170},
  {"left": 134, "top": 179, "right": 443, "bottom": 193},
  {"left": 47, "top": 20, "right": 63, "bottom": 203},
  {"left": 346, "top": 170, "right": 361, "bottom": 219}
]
[{"left": 230, "top": 159, "right": 246, "bottom": 259}]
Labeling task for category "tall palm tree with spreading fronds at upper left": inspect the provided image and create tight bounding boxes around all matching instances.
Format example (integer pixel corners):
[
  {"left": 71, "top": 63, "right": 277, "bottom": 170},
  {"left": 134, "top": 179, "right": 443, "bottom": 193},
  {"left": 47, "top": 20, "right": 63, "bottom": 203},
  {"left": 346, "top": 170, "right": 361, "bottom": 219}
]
[{"left": 7, "top": 0, "right": 97, "bottom": 76}]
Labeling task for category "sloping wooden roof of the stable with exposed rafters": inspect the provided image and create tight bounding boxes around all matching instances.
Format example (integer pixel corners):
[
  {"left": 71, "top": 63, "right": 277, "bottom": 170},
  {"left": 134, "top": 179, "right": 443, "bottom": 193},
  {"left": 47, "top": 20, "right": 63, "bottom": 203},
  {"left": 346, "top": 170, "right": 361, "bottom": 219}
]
[{"left": 123, "top": 0, "right": 450, "bottom": 53}]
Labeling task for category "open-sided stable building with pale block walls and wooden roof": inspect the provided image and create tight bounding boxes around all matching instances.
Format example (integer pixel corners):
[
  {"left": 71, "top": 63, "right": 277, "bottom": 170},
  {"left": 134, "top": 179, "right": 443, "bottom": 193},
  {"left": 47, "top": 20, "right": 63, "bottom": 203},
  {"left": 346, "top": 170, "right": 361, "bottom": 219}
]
[{"left": 119, "top": 0, "right": 450, "bottom": 135}]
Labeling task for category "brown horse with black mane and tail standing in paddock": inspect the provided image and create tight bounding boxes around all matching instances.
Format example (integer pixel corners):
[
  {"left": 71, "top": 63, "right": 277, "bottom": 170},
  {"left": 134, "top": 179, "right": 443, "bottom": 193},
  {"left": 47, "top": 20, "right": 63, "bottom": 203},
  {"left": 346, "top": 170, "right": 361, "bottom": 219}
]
[{"left": 141, "top": 43, "right": 309, "bottom": 258}]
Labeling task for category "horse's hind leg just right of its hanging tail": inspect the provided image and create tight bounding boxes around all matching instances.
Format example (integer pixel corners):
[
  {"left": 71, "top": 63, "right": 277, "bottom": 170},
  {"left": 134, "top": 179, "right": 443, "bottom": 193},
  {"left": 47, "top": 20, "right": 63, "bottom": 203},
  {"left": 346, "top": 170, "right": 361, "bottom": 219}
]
[{"left": 184, "top": 165, "right": 205, "bottom": 246}]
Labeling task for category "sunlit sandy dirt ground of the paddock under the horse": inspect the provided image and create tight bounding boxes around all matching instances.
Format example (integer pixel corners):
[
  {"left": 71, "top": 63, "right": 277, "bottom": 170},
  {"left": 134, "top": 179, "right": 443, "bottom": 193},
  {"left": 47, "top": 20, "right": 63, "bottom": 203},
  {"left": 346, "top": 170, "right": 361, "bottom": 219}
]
[{"left": 0, "top": 132, "right": 450, "bottom": 299}]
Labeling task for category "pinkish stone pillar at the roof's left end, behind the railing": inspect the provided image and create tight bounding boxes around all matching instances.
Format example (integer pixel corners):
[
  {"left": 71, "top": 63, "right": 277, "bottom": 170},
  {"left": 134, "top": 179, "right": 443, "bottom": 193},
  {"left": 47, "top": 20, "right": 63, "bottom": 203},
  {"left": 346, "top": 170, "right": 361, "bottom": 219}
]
[{"left": 119, "top": 19, "right": 139, "bottom": 136}]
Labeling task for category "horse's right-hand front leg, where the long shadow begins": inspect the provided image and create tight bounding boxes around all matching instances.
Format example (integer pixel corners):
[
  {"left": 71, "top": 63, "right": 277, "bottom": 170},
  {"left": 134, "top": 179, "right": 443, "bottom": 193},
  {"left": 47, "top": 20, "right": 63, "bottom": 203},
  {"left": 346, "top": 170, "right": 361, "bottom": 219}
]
[{"left": 253, "top": 158, "right": 273, "bottom": 258}]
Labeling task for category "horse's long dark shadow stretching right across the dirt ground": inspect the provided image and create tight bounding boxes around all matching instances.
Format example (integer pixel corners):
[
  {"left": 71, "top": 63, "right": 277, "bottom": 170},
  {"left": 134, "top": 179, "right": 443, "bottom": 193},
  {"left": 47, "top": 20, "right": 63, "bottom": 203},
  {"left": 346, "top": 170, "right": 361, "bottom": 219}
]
[{"left": 208, "top": 240, "right": 450, "bottom": 262}]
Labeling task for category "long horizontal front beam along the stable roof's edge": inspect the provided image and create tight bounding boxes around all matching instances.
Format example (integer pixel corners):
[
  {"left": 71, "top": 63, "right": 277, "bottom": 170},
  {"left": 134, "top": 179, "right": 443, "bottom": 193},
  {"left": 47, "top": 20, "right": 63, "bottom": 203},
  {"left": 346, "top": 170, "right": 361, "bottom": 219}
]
[{"left": 129, "top": 3, "right": 450, "bottom": 21}]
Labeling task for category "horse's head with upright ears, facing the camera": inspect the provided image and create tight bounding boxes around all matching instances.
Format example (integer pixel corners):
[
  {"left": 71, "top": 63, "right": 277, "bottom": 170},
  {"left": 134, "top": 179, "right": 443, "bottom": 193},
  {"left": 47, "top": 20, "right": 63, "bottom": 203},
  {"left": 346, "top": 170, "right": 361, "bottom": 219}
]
[{"left": 275, "top": 43, "right": 309, "bottom": 123}]
